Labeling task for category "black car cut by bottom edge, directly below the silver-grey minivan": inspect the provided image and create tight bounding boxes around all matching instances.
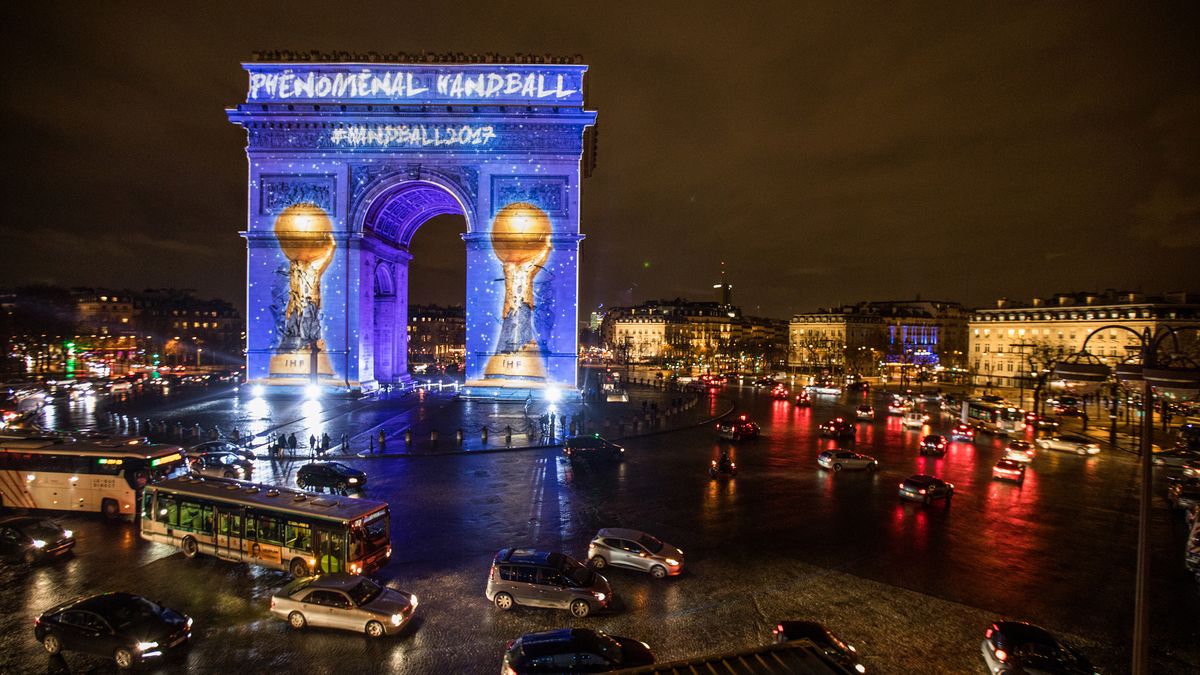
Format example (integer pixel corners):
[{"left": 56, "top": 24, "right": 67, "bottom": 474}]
[{"left": 504, "top": 628, "right": 654, "bottom": 675}]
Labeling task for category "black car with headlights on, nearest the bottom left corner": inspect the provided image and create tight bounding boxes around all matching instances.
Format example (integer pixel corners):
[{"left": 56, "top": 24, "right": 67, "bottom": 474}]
[{"left": 34, "top": 593, "right": 192, "bottom": 668}]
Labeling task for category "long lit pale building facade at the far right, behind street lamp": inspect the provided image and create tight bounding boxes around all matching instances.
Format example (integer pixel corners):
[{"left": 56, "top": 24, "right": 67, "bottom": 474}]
[{"left": 968, "top": 289, "right": 1200, "bottom": 388}]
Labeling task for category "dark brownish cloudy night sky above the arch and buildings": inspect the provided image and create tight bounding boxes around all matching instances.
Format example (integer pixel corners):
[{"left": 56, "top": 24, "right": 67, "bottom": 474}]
[{"left": 0, "top": 2, "right": 1200, "bottom": 317}]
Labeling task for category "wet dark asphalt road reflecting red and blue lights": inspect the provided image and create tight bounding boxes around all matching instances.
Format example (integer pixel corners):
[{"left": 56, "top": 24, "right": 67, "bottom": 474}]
[{"left": 0, "top": 381, "right": 1200, "bottom": 674}]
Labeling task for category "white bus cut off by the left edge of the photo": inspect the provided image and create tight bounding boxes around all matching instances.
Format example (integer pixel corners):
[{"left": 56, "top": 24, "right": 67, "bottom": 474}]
[{"left": 0, "top": 435, "right": 185, "bottom": 518}]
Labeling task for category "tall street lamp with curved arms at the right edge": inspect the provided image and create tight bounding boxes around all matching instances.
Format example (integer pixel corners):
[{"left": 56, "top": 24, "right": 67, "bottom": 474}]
[{"left": 1055, "top": 324, "right": 1200, "bottom": 675}]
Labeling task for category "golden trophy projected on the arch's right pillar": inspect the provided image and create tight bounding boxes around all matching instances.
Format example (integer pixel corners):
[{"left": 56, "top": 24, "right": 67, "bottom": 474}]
[{"left": 481, "top": 202, "right": 552, "bottom": 387}]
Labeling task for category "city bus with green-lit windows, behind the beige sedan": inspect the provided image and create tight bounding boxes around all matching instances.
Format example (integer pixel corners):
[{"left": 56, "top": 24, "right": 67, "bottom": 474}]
[{"left": 142, "top": 476, "right": 391, "bottom": 578}]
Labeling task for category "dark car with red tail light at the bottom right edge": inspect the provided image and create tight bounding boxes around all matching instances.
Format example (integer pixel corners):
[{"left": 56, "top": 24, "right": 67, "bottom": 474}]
[{"left": 979, "top": 621, "right": 1096, "bottom": 675}]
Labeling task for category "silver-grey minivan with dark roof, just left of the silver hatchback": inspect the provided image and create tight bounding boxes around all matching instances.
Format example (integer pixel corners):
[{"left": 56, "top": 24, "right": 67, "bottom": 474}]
[{"left": 484, "top": 548, "right": 612, "bottom": 617}]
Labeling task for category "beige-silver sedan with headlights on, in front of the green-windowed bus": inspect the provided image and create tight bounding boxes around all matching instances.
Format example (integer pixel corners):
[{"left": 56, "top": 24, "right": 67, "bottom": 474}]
[{"left": 271, "top": 572, "right": 418, "bottom": 638}]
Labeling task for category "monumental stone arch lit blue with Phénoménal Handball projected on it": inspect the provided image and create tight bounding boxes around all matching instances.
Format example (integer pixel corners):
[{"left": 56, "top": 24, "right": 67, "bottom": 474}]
[{"left": 228, "top": 54, "right": 595, "bottom": 396}]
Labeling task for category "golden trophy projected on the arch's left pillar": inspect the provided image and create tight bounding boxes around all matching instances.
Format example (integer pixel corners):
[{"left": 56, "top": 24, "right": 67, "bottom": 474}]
[{"left": 268, "top": 203, "right": 337, "bottom": 380}]
